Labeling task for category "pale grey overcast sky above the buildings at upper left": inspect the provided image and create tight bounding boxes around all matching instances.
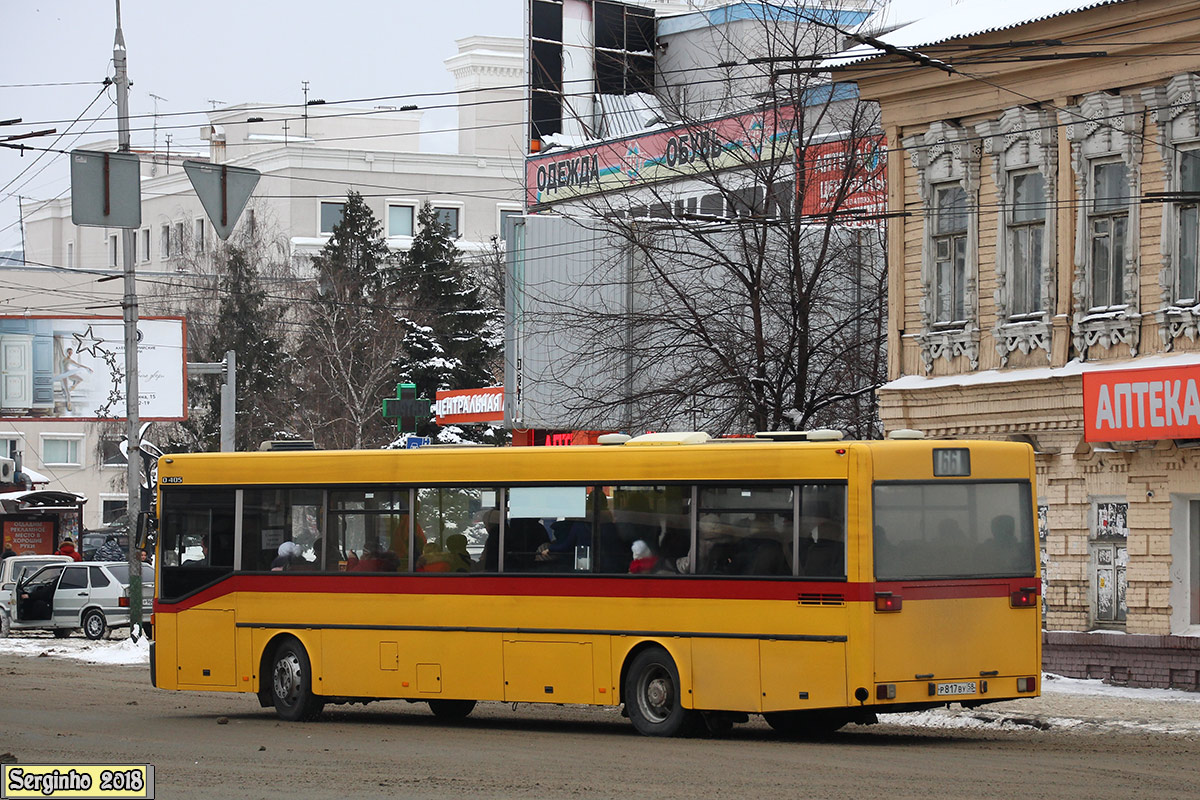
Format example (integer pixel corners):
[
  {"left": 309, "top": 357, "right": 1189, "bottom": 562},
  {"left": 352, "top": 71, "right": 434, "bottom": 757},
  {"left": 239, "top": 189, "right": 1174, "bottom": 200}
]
[{"left": 0, "top": 0, "right": 523, "bottom": 249}]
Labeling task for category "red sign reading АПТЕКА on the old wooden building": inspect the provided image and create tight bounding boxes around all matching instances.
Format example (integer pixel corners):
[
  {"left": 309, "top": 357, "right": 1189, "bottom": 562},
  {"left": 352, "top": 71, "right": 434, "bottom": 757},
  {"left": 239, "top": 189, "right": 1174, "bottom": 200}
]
[{"left": 1084, "top": 365, "right": 1200, "bottom": 441}]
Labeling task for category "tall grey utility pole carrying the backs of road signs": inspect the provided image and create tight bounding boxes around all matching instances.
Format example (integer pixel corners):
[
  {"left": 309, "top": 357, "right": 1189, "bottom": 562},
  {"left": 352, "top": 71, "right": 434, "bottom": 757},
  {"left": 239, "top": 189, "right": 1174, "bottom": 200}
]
[{"left": 113, "top": 0, "right": 142, "bottom": 642}]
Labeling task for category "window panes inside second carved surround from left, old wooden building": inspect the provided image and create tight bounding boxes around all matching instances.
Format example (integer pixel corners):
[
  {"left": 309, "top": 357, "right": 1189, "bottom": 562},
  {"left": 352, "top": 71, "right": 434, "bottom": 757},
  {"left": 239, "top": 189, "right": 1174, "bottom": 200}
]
[{"left": 1008, "top": 169, "right": 1046, "bottom": 319}]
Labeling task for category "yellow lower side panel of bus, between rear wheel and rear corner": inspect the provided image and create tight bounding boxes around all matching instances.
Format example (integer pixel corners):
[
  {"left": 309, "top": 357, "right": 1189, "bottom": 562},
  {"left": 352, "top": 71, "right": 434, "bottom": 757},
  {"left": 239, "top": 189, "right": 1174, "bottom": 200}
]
[{"left": 758, "top": 640, "right": 847, "bottom": 711}]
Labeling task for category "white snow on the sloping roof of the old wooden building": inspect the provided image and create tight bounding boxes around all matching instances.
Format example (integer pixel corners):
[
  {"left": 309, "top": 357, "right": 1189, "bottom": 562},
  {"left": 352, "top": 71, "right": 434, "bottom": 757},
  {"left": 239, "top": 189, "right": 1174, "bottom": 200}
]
[{"left": 827, "top": 0, "right": 1127, "bottom": 65}]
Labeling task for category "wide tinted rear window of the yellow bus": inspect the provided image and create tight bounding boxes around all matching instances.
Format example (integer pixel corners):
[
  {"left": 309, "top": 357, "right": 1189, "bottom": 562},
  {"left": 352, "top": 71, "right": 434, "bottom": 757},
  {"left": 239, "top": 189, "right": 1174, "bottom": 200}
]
[{"left": 874, "top": 481, "right": 1036, "bottom": 581}]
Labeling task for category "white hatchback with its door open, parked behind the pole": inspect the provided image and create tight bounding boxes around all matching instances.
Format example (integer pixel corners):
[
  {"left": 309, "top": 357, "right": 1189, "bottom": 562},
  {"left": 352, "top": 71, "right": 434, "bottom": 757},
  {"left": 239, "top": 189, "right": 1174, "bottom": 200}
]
[{"left": 11, "top": 561, "right": 154, "bottom": 639}]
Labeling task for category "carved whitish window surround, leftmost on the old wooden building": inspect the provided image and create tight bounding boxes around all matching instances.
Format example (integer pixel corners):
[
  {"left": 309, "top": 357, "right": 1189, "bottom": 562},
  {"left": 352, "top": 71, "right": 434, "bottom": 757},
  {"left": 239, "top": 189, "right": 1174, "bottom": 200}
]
[{"left": 902, "top": 121, "right": 983, "bottom": 373}]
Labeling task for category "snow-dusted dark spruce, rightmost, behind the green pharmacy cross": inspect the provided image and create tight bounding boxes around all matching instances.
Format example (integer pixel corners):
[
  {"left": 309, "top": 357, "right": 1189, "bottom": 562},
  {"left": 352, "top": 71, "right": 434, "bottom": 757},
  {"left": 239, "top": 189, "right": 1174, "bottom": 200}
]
[{"left": 396, "top": 203, "right": 503, "bottom": 441}]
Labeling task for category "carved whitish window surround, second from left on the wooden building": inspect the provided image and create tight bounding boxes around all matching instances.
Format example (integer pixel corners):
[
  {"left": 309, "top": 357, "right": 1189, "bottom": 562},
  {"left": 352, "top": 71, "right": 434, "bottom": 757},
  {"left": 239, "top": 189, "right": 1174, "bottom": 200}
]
[{"left": 976, "top": 107, "right": 1058, "bottom": 366}]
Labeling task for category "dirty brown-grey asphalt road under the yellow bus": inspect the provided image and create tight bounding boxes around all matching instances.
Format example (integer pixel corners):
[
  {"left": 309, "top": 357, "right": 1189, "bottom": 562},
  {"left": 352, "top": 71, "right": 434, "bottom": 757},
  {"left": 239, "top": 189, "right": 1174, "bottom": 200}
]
[{"left": 0, "top": 654, "right": 1200, "bottom": 800}]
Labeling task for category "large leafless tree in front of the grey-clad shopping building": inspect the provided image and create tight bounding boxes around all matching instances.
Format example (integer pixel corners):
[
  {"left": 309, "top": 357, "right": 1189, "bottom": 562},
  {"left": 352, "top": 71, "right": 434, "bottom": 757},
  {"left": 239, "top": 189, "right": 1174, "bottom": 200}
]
[{"left": 522, "top": 1, "right": 886, "bottom": 437}]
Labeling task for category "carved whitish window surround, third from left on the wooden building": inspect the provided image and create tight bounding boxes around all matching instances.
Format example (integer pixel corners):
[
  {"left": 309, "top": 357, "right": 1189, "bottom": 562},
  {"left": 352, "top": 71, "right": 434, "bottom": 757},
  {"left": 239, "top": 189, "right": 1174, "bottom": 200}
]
[{"left": 1058, "top": 92, "right": 1146, "bottom": 360}]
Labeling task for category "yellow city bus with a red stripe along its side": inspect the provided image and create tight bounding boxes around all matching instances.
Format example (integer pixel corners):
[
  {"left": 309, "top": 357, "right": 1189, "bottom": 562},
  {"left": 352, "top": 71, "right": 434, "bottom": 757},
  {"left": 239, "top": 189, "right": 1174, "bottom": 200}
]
[{"left": 151, "top": 434, "right": 1042, "bottom": 735}]
